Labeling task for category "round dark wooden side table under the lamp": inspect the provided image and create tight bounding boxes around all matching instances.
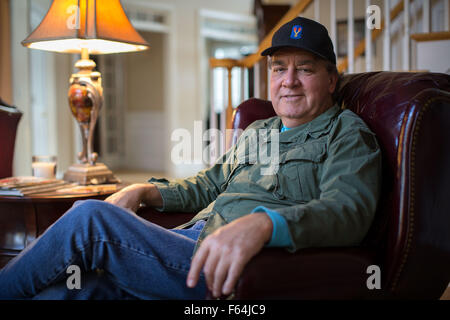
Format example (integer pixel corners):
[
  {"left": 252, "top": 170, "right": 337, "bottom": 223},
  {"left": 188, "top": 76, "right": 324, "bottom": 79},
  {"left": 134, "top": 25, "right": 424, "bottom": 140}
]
[{"left": 0, "top": 192, "right": 113, "bottom": 268}]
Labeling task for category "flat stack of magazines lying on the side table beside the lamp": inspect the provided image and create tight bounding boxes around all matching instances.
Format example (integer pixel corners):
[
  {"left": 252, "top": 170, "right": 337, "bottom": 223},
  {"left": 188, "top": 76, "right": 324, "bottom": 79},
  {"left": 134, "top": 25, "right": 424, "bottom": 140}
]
[{"left": 0, "top": 177, "right": 76, "bottom": 197}]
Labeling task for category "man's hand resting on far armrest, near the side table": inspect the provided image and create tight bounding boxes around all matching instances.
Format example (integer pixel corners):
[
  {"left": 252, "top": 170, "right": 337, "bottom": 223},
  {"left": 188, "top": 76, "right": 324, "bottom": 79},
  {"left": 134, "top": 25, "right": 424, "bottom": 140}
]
[{"left": 105, "top": 183, "right": 163, "bottom": 212}]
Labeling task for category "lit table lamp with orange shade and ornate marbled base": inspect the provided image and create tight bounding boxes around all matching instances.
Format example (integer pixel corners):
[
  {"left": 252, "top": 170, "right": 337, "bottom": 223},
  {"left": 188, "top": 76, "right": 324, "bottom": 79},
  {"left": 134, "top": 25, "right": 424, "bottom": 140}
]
[{"left": 22, "top": 0, "right": 148, "bottom": 185}]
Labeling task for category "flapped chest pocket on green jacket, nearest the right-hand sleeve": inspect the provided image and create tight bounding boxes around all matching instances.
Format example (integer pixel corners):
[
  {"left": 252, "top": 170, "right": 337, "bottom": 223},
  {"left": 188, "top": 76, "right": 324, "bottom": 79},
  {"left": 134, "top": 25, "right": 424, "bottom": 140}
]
[{"left": 274, "top": 143, "right": 326, "bottom": 203}]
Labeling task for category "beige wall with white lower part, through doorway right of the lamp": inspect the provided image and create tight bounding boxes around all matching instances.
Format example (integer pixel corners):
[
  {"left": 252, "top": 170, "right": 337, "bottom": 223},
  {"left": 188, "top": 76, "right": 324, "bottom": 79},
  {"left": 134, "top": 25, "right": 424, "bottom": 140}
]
[{"left": 120, "top": 32, "right": 167, "bottom": 172}]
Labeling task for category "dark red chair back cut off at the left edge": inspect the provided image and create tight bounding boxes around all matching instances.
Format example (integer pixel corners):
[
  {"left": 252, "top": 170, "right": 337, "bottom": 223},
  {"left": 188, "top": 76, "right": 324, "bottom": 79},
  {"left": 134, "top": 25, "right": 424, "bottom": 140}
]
[{"left": 0, "top": 105, "right": 22, "bottom": 178}]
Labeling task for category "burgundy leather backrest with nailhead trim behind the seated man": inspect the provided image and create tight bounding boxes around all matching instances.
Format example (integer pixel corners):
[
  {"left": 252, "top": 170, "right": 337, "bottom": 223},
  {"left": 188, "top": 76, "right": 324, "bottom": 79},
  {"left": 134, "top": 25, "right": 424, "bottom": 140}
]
[{"left": 233, "top": 72, "right": 450, "bottom": 298}]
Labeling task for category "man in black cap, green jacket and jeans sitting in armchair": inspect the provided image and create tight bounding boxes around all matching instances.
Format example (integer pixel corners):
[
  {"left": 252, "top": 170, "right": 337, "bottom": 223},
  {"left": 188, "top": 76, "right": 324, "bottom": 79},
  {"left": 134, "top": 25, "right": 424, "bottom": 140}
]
[{"left": 0, "top": 18, "right": 381, "bottom": 299}]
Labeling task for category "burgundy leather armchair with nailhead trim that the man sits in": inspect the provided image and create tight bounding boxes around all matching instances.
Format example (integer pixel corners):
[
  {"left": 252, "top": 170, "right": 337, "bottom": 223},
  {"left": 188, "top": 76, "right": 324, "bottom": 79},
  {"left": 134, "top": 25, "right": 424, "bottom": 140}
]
[{"left": 138, "top": 72, "right": 450, "bottom": 299}]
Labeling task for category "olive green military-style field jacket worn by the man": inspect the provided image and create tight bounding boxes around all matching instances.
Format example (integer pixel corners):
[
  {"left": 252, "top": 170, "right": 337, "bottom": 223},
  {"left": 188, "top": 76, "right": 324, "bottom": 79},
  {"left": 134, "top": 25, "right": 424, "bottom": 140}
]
[{"left": 149, "top": 105, "right": 381, "bottom": 255}]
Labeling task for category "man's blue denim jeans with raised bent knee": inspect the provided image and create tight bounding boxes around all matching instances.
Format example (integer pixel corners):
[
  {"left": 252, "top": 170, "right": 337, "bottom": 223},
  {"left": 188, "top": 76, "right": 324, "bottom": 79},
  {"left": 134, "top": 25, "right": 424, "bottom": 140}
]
[{"left": 0, "top": 200, "right": 206, "bottom": 299}]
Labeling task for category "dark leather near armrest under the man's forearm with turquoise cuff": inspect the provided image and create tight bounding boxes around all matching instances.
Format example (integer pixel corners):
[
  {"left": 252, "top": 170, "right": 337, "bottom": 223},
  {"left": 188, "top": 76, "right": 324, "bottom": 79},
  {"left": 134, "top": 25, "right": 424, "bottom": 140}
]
[{"left": 221, "top": 247, "right": 376, "bottom": 299}]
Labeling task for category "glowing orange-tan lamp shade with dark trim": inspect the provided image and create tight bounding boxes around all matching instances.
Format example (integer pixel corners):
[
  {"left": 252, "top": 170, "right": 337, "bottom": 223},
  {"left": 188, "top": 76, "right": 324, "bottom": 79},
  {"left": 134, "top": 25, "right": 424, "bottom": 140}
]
[{"left": 22, "top": 0, "right": 148, "bottom": 54}]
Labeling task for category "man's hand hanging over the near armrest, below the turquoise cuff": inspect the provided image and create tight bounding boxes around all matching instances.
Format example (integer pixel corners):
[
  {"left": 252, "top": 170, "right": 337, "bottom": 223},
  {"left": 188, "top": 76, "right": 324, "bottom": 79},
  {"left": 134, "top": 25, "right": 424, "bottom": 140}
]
[{"left": 187, "top": 213, "right": 272, "bottom": 297}]
